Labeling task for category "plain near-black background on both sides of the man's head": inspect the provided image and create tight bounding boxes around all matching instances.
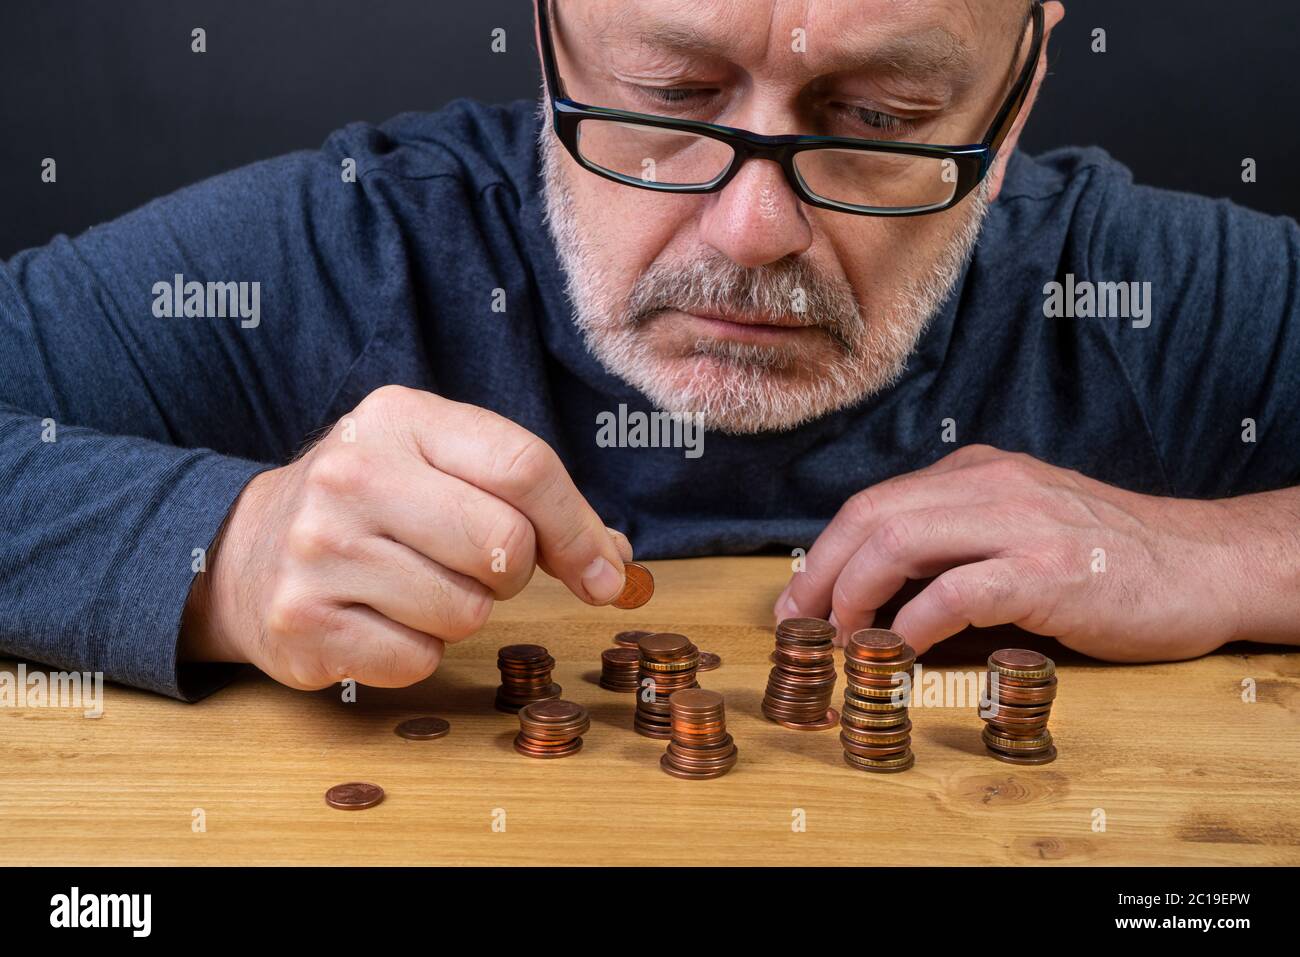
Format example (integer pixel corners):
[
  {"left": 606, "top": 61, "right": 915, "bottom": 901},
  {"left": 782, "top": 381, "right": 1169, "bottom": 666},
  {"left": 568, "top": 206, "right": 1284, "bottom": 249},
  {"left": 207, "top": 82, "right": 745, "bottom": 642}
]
[{"left": 0, "top": 0, "right": 1300, "bottom": 259}]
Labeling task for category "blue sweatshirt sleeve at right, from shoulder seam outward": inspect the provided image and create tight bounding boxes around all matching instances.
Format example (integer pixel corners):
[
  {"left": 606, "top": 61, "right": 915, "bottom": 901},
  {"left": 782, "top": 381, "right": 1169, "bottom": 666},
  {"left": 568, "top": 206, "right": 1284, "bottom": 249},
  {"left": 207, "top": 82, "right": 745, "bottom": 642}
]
[{"left": 1088, "top": 163, "right": 1300, "bottom": 498}]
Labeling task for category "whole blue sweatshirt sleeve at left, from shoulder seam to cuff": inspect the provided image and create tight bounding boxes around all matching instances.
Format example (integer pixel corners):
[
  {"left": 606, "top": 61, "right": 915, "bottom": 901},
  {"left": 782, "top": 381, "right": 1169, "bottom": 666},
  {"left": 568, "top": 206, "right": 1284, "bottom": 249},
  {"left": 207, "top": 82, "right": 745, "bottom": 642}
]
[{"left": 0, "top": 125, "right": 410, "bottom": 700}]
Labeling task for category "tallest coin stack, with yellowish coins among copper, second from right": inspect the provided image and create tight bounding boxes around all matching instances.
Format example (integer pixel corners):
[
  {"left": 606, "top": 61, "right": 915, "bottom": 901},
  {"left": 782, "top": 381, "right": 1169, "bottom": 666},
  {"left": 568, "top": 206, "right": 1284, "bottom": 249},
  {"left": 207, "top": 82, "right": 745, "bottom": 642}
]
[{"left": 840, "top": 628, "right": 917, "bottom": 772}]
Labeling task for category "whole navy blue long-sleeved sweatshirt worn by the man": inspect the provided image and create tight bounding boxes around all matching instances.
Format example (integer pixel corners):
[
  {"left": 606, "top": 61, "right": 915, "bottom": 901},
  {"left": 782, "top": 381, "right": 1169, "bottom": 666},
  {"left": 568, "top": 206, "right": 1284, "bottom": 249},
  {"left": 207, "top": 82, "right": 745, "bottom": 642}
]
[{"left": 0, "top": 101, "right": 1300, "bottom": 700}]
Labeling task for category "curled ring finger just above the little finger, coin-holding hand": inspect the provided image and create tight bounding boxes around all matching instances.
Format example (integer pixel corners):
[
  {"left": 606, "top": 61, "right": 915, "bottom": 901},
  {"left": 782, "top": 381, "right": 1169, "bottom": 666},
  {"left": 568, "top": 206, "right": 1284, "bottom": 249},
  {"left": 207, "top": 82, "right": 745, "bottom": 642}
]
[{"left": 326, "top": 536, "right": 496, "bottom": 642}]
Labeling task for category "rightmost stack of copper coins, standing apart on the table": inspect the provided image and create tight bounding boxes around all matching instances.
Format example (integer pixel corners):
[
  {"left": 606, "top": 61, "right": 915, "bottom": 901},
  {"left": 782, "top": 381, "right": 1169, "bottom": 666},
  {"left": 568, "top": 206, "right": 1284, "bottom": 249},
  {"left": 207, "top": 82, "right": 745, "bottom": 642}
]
[{"left": 979, "top": 648, "right": 1057, "bottom": 765}]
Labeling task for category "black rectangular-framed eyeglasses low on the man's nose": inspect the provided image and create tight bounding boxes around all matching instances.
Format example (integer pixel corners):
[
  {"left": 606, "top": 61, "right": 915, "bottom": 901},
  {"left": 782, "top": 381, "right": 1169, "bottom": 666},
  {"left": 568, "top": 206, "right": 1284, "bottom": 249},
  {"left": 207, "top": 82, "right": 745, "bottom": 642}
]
[{"left": 537, "top": 0, "right": 1044, "bottom": 216}]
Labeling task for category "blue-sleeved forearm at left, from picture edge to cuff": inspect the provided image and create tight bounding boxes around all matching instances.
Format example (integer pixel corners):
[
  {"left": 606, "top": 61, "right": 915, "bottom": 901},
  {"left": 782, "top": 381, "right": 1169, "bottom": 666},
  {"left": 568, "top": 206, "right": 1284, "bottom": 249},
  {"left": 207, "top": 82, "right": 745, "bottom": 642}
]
[{"left": 0, "top": 407, "right": 261, "bottom": 698}]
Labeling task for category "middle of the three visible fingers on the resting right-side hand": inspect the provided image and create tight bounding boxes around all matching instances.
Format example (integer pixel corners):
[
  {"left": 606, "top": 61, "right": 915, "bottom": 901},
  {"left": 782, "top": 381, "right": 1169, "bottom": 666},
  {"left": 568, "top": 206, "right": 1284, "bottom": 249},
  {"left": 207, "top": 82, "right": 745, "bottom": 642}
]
[{"left": 831, "top": 507, "right": 1006, "bottom": 638}]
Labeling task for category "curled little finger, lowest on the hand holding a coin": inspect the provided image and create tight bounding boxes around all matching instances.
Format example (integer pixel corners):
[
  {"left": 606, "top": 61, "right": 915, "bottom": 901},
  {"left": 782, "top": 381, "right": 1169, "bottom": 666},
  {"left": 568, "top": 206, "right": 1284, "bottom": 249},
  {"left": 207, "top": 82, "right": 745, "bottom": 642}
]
[{"left": 295, "top": 605, "right": 445, "bottom": 688}]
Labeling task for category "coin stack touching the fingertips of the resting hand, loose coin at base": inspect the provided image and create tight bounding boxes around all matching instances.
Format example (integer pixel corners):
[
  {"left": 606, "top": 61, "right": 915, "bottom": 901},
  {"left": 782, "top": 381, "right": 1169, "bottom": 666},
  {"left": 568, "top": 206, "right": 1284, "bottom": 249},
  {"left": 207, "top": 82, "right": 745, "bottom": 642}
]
[{"left": 763, "top": 618, "right": 840, "bottom": 731}]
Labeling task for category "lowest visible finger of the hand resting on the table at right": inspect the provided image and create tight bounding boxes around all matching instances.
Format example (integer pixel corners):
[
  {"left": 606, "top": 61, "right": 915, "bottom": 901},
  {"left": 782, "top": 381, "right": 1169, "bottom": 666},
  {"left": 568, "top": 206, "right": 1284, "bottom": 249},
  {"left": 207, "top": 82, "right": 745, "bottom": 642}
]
[{"left": 893, "top": 558, "right": 1045, "bottom": 654}]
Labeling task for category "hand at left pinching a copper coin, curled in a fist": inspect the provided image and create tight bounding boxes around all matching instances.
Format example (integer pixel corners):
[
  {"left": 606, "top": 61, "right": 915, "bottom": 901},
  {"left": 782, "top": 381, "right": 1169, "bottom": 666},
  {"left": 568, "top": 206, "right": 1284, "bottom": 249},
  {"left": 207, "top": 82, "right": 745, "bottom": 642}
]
[{"left": 181, "top": 386, "right": 632, "bottom": 689}]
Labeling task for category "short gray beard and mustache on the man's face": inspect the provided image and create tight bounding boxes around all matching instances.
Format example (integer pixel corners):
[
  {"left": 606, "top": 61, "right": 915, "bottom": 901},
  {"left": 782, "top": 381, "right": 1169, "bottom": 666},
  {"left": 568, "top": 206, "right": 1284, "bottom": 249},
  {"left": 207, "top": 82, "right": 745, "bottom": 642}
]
[{"left": 538, "top": 98, "right": 989, "bottom": 434}]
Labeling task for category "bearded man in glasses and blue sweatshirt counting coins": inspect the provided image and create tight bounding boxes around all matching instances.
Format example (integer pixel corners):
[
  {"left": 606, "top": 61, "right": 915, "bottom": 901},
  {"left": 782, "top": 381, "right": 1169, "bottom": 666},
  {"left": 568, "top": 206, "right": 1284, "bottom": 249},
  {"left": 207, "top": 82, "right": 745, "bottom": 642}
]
[{"left": 0, "top": 0, "right": 1300, "bottom": 698}]
